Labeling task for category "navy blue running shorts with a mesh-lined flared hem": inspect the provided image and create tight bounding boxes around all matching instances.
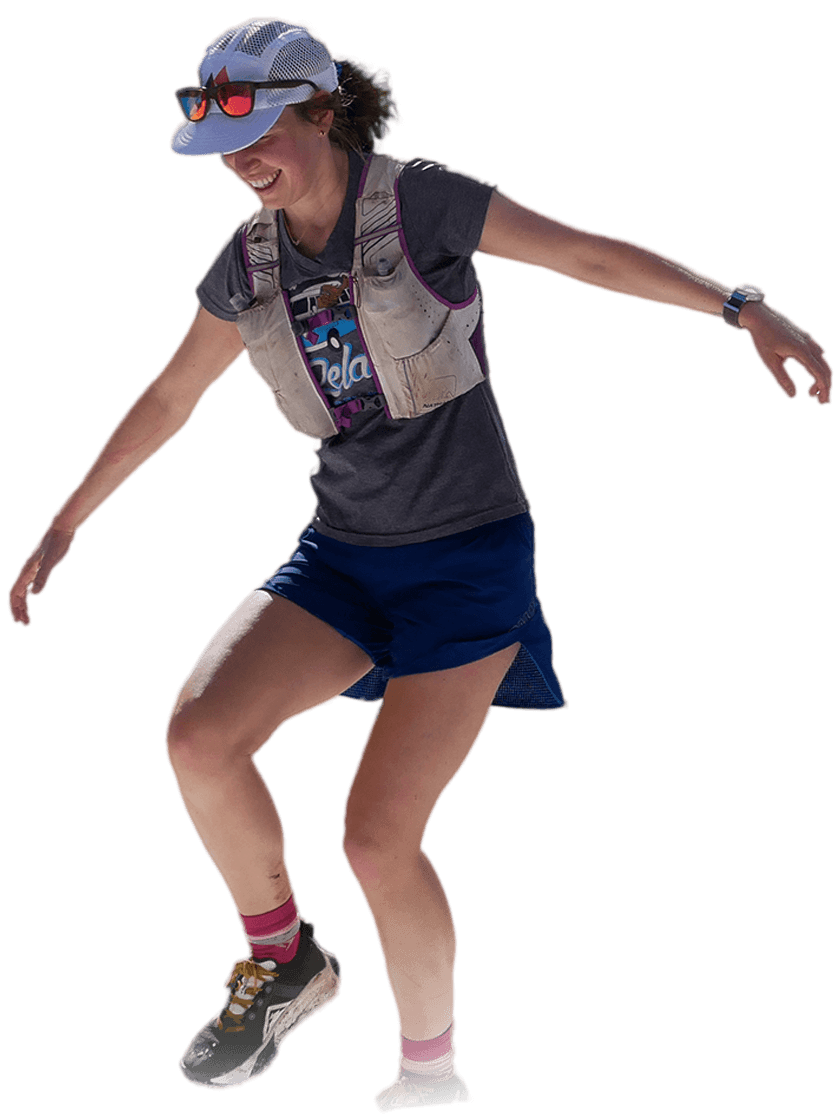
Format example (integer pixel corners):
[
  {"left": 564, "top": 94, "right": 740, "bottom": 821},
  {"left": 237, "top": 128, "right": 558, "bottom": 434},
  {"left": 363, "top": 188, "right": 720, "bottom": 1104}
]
[{"left": 256, "top": 513, "right": 569, "bottom": 710}]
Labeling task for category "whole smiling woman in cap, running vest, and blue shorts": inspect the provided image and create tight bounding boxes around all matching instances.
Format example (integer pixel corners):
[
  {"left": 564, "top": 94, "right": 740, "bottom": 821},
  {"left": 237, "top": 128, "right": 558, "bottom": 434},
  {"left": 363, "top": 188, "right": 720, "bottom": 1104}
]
[{"left": 10, "top": 19, "right": 831, "bottom": 1111}]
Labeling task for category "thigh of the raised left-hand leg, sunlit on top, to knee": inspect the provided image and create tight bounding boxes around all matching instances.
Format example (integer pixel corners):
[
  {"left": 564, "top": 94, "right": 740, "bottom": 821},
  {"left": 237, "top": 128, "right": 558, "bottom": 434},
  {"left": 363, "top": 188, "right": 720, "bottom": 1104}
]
[{"left": 170, "top": 590, "right": 373, "bottom": 751}]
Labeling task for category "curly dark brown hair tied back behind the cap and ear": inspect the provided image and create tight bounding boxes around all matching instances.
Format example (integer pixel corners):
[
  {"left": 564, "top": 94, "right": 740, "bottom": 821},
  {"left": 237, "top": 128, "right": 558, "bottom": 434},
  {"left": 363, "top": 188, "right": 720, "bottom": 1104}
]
[{"left": 292, "top": 55, "right": 402, "bottom": 154}]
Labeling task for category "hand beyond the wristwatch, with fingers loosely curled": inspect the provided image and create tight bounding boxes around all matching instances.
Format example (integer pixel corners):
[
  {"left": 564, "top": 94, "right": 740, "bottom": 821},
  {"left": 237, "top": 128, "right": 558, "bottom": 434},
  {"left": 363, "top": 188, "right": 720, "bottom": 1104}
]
[{"left": 738, "top": 303, "right": 834, "bottom": 407}]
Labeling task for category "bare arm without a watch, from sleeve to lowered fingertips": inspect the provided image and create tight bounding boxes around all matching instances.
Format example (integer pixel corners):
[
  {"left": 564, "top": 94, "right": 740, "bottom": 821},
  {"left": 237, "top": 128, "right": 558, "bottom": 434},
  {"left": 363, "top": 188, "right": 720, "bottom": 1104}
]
[{"left": 9, "top": 307, "right": 245, "bottom": 628}]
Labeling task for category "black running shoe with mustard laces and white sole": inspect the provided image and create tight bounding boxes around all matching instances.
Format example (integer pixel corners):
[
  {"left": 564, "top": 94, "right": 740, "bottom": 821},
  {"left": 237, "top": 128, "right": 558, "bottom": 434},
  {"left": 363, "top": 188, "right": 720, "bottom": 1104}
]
[{"left": 179, "top": 919, "right": 341, "bottom": 1090}]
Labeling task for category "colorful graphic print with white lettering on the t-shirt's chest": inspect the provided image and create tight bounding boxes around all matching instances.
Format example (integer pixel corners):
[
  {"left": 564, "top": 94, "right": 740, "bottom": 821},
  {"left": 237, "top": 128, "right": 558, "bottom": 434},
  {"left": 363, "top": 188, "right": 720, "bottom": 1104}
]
[{"left": 289, "top": 275, "right": 376, "bottom": 407}]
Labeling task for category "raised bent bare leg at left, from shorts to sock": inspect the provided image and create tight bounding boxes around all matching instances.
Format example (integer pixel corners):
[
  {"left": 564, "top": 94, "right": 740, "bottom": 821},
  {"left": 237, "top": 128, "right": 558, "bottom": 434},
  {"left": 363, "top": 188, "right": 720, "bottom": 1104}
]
[{"left": 166, "top": 591, "right": 373, "bottom": 915}]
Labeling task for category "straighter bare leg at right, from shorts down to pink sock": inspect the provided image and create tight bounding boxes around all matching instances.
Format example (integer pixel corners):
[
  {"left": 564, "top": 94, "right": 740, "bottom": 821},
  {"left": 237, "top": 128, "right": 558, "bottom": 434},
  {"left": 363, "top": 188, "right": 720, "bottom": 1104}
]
[{"left": 344, "top": 643, "right": 519, "bottom": 1040}]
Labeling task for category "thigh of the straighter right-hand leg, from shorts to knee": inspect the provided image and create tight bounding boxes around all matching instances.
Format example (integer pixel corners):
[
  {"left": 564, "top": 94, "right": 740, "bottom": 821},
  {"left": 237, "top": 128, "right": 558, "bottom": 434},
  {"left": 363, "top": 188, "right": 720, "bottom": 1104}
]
[{"left": 344, "top": 643, "right": 519, "bottom": 847}]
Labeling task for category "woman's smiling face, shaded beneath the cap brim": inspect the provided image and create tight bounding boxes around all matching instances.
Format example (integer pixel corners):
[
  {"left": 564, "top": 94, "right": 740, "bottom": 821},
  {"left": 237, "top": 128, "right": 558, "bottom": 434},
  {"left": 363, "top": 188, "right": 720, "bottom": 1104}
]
[{"left": 220, "top": 106, "right": 331, "bottom": 209}]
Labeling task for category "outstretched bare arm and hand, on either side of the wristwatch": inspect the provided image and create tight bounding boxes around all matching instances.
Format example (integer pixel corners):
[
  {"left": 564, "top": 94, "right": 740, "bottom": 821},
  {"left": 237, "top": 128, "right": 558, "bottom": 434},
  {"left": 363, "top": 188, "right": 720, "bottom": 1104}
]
[{"left": 478, "top": 191, "right": 833, "bottom": 404}]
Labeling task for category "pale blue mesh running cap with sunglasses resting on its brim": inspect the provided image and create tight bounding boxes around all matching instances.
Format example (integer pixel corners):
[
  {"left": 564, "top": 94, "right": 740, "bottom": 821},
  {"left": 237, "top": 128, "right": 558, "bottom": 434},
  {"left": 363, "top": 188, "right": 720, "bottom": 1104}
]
[{"left": 169, "top": 17, "right": 338, "bottom": 155}]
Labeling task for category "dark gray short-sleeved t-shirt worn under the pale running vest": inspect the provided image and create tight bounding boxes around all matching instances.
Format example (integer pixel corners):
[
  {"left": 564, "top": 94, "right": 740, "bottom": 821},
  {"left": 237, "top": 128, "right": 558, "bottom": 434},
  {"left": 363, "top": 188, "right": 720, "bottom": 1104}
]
[{"left": 195, "top": 153, "right": 531, "bottom": 546}]
